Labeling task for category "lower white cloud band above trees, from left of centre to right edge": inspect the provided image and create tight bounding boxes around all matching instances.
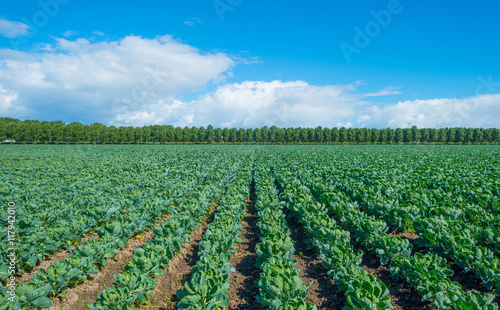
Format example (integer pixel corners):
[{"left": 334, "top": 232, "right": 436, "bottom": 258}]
[{"left": 112, "top": 81, "right": 500, "bottom": 128}]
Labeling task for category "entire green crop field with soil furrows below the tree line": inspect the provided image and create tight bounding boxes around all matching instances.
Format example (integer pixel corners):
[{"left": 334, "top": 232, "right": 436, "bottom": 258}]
[{"left": 0, "top": 145, "right": 500, "bottom": 310}]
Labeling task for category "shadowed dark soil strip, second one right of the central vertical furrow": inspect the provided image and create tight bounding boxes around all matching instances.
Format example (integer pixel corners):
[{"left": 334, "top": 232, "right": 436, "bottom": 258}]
[{"left": 354, "top": 245, "right": 430, "bottom": 310}]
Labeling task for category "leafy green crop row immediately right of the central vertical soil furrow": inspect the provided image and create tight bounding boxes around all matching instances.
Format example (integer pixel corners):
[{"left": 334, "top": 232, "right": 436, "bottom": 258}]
[{"left": 255, "top": 155, "right": 317, "bottom": 310}]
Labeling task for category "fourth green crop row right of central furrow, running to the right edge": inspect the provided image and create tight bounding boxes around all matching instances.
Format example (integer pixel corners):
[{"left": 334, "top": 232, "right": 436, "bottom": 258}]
[{"left": 300, "top": 154, "right": 500, "bottom": 295}]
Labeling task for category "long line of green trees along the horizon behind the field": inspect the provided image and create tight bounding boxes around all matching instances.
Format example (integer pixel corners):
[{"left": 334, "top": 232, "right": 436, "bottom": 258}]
[{"left": 0, "top": 117, "right": 500, "bottom": 144}]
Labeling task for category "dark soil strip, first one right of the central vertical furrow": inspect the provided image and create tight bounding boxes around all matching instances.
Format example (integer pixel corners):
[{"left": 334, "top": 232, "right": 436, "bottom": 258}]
[{"left": 287, "top": 214, "right": 345, "bottom": 310}]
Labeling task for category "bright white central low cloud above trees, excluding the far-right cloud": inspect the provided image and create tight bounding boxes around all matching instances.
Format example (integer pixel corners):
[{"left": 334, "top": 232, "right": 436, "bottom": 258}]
[{"left": 110, "top": 81, "right": 398, "bottom": 127}]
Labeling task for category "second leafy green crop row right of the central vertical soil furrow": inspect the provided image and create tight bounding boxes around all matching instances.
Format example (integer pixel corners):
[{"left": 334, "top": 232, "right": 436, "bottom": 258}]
[{"left": 269, "top": 156, "right": 392, "bottom": 309}]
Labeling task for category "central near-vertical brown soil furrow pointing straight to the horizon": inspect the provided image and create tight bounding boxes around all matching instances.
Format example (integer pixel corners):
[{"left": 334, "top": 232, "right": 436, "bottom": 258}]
[{"left": 228, "top": 182, "right": 263, "bottom": 310}]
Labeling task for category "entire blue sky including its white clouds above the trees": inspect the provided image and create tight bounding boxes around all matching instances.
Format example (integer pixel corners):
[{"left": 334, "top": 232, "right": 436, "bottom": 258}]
[{"left": 0, "top": 0, "right": 500, "bottom": 128}]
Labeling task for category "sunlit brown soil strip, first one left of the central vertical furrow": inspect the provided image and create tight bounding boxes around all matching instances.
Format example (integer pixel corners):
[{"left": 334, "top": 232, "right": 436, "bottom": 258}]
[{"left": 138, "top": 206, "right": 217, "bottom": 310}]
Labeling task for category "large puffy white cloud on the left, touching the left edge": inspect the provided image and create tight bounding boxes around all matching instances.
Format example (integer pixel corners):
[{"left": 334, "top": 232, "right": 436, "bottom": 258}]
[{"left": 0, "top": 36, "right": 234, "bottom": 122}]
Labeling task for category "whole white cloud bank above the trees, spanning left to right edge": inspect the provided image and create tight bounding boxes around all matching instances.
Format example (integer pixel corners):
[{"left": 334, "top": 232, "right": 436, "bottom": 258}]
[{"left": 0, "top": 36, "right": 500, "bottom": 128}]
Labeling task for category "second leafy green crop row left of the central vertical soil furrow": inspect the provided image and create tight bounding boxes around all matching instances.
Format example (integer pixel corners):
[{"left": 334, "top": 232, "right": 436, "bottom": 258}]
[{"left": 87, "top": 155, "right": 246, "bottom": 310}]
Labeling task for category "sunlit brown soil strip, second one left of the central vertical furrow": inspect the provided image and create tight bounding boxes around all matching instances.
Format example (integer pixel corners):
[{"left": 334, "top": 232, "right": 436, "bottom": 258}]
[{"left": 49, "top": 214, "right": 172, "bottom": 310}]
